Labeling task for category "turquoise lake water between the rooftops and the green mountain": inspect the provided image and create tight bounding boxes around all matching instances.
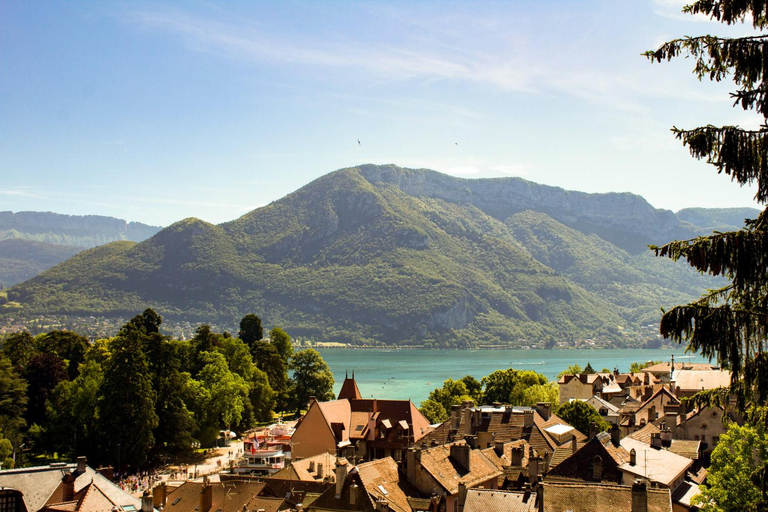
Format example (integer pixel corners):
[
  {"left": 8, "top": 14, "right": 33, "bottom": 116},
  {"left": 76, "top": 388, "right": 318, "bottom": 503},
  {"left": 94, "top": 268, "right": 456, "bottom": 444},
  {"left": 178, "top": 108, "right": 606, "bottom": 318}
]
[{"left": 319, "top": 347, "right": 708, "bottom": 405}]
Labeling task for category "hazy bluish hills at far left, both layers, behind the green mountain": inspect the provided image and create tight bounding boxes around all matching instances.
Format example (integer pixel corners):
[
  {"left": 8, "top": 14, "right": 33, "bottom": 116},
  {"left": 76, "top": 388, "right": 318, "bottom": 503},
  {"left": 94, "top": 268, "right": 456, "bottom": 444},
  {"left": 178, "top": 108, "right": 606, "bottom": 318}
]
[{"left": 0, "top": 211, "right": 160, "bottom": 287}]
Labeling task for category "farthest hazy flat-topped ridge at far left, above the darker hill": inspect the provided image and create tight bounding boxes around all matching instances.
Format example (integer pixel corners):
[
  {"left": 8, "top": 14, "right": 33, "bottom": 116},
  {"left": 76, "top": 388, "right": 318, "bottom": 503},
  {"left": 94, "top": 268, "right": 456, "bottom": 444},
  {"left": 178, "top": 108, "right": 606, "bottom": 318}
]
[{"left": 0, "top": 211, "right": 161, "bottom": 247}]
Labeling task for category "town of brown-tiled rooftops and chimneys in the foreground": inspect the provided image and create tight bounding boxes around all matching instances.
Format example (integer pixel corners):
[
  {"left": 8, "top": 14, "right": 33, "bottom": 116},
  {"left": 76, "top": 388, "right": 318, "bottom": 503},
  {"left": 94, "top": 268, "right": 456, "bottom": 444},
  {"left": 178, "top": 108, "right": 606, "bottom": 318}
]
[{"left": 0, "top": 359, "right": 740, "bottom": 512}]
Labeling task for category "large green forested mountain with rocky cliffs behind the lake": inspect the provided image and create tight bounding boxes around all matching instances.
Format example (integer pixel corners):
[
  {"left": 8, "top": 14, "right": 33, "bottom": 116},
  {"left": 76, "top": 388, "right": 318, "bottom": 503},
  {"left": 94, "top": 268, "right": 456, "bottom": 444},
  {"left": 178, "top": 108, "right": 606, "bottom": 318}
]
[{"left": 0, "top": 165, "right": 758, "bottom": 347}]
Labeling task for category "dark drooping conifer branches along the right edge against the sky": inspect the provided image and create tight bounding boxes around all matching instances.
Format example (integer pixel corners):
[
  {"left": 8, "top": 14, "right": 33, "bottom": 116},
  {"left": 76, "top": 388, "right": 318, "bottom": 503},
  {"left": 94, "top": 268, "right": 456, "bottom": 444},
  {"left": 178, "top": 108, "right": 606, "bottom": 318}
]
[{"left": 646, "top": 0, "right": 768, "bottom": 410}]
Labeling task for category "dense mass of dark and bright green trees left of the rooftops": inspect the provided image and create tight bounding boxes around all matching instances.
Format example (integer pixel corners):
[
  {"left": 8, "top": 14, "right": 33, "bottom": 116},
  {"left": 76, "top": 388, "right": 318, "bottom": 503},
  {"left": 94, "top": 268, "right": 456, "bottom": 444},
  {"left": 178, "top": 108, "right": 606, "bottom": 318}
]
[{"left": 0, "top": 309, "right": 334, "bottom": 468}]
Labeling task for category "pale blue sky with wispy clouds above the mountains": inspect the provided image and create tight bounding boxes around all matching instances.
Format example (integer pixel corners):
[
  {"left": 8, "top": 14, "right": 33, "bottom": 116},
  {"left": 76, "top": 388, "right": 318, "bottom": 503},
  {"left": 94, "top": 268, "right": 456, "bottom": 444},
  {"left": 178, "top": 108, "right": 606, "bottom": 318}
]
[{"left": 0, "top": 0, "right": 760, "bottom": 226}]
